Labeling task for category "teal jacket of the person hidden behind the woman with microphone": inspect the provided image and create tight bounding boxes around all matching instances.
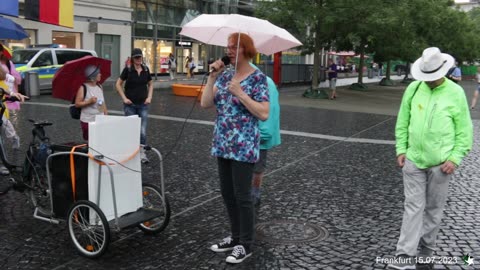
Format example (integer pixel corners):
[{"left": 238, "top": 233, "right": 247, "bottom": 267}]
[{"left": 258, "top": 76, "right": 282, "bottom": 150}]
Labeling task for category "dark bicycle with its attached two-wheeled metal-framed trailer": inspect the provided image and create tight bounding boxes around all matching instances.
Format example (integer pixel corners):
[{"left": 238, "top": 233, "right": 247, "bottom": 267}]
[{"left": 0, "top": 88, "right": 171, "bottom": 258}]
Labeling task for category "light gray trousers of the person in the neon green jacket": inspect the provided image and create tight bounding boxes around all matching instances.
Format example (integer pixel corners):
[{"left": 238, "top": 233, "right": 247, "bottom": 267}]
[{"left": 396, "top": 159, "right": 452, "bottom": 256}]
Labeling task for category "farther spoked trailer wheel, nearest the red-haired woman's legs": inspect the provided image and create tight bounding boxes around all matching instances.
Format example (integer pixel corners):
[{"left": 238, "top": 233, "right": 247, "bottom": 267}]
[{"left": 138, "top": 184, "right": 170, "bottom": 234}]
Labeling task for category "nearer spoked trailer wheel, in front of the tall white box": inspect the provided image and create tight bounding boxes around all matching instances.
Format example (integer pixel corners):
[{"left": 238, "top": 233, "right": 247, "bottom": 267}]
[{"left": 67, "top": 200, "right": 110, "bottom": 258}]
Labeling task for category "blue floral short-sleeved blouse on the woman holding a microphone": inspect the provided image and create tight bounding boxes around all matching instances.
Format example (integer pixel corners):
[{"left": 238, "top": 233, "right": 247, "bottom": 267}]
[{"left": 211, "top": 70, "right": 269, "bottom": 163}]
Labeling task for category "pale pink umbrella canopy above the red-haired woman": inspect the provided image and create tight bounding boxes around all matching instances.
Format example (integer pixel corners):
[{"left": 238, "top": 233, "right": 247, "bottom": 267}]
[{"left": 180, "top": 14, "right": 302, "bottom": 55}]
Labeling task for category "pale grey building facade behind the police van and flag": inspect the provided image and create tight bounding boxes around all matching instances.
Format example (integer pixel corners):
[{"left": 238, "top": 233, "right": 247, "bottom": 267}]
[{"left": 7, "top": 0, "right": 133, "bottom": 78}]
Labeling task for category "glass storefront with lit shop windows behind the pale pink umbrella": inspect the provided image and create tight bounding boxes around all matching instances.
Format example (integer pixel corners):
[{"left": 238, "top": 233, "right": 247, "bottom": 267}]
[{"left": 131, "top": 0, "right": 305, "bottom": 74}]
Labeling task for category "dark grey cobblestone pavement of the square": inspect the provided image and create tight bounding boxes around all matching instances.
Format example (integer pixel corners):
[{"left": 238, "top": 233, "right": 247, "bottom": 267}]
[{"left": 0, "top": 85, "right": 480, "bottom": 270}]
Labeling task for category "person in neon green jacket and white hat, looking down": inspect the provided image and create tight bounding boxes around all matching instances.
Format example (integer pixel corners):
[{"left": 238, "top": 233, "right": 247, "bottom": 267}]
[{"left": 389, "top": 47, "right": 473, "bottom": 269}]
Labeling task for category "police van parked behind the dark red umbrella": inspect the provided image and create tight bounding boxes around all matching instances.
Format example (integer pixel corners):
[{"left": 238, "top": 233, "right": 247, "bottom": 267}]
[{"left": 12, "top": 47, "right": 97, "bottom": 92}]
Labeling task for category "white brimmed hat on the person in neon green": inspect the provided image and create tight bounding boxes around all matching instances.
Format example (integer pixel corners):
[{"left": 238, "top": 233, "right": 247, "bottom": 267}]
[{"left": 411, "top": 47, "right": 455, "bottom": 82}]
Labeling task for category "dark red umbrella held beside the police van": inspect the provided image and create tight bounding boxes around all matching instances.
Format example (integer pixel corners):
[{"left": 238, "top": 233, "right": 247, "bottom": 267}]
[{"left": 52, "top": 55, "right": 112, "bottom": 101}]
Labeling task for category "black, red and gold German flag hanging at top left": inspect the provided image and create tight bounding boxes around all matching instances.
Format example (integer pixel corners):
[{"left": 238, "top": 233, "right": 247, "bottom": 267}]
[{"left": 25, "top": 0, "right": 73, "bottom": 28}]
